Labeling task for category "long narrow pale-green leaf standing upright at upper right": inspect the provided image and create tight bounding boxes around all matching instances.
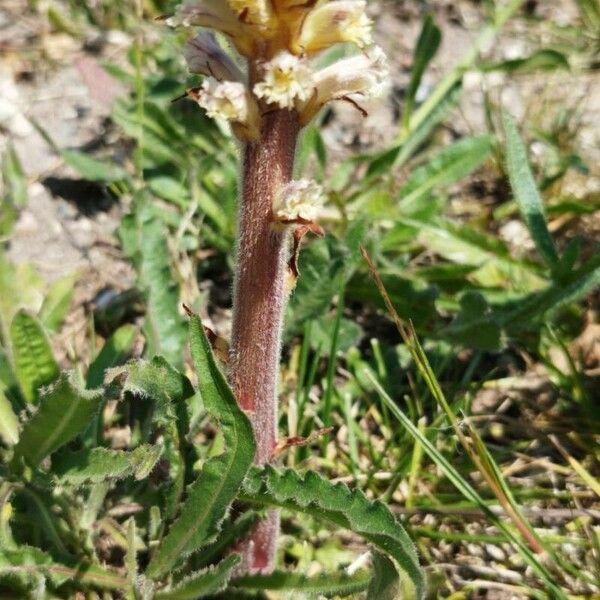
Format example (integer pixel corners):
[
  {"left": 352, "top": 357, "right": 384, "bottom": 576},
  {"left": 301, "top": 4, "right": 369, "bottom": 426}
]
[{"left": 502, "top": 113, "right": 559, "bottom": 270}]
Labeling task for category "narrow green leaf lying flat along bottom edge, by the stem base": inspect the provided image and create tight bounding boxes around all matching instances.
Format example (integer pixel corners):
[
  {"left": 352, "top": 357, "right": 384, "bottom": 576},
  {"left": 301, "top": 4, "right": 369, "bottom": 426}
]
[{"left": 231, "top": 571, "right": 371, "bottom": 598}]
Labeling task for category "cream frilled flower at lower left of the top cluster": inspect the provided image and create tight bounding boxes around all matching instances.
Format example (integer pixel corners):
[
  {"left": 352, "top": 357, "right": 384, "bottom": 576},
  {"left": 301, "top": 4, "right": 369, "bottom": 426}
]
[{"left": 188, "top": 77, "right": 260, "bottom": 140}]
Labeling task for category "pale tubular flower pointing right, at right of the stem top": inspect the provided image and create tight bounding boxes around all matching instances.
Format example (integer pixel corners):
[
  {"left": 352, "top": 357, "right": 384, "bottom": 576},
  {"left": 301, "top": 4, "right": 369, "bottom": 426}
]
[{"left": 300, "top": 46, "right": 389, "bottom": 123}]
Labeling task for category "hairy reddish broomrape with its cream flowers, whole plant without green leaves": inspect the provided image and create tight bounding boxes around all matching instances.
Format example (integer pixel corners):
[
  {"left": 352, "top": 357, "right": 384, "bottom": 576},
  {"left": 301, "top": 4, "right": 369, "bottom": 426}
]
[{"left": 167, "top": 0, "right": 388, "bottom": 572}]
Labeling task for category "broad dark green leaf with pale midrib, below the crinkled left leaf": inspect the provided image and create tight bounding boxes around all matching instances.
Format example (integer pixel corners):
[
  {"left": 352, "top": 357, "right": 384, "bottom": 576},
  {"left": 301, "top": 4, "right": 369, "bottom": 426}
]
[{"left": 15, "top": 373, "right": 102, "bottom": 467}]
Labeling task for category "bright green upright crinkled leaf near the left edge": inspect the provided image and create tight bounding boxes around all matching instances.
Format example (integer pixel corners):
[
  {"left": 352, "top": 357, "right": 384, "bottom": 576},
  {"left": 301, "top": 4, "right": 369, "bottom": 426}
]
[{"left": 10, "top": 310, "right": 60, "bottom": 403}]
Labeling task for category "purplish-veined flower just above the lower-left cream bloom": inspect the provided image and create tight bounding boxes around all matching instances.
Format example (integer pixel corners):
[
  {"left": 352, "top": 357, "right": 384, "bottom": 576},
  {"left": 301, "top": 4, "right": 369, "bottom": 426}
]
[{"left": 183, "top": 31, "right": 244, "bottom": 81}]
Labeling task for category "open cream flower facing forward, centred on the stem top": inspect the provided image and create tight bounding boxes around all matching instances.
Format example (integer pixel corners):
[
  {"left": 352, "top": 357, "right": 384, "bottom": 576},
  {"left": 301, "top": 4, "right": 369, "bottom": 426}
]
[{"left": 254, "top": 51, "right": 314, "bottom": 109}]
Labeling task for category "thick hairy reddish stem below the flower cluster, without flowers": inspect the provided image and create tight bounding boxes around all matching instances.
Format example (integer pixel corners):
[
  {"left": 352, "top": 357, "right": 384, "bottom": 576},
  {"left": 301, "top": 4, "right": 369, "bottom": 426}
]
[{"left": 230, "top": 110, "right": 300, "bottom": 573}]
